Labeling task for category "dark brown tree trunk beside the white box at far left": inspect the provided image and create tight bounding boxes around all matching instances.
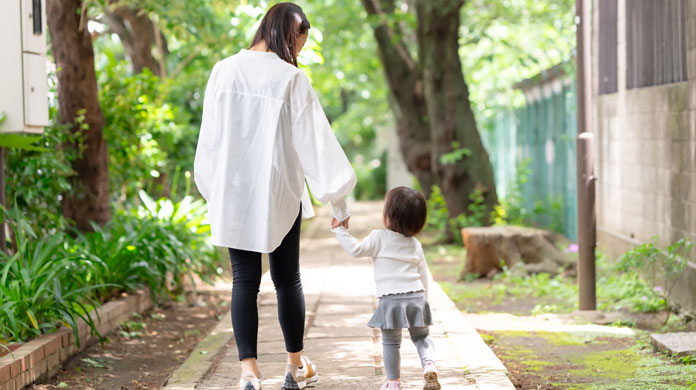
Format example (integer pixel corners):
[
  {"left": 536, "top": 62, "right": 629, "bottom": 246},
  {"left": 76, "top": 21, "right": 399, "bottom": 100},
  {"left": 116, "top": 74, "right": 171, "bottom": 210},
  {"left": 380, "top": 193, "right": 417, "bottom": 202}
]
[{"left": 46, "top": 0, "right": 111, "bottom": 231}]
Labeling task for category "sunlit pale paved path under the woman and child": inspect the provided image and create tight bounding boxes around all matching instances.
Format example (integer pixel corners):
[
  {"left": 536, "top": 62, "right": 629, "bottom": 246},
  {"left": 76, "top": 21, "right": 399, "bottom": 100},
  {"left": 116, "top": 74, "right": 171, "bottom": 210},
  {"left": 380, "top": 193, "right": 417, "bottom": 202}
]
[{"left": 165, "top": 203, "right": 514, "bottom": 390}]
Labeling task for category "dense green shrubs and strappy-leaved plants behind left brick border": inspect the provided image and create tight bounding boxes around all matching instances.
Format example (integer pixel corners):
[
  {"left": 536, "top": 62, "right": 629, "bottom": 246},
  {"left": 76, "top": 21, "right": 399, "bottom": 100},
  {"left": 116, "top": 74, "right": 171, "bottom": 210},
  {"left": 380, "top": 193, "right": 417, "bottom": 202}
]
[{"left": 0, "top": 52, "right": 226, "bottom": 348}]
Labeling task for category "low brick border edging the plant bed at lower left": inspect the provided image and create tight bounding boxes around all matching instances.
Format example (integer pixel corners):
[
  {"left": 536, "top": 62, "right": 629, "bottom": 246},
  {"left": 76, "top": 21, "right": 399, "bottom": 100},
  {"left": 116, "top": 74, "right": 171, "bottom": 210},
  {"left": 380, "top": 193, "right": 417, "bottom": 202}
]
[{"left": 0, "top": 288, "right": 152, "bottom": 390}]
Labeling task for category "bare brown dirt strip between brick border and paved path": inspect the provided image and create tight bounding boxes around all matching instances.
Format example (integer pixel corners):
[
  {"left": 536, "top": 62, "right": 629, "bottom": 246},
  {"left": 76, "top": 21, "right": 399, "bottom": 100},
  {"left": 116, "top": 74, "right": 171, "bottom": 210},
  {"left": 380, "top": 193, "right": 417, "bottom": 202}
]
[{"left": 29, "top": 291, "right": 229, "bottom": 390}]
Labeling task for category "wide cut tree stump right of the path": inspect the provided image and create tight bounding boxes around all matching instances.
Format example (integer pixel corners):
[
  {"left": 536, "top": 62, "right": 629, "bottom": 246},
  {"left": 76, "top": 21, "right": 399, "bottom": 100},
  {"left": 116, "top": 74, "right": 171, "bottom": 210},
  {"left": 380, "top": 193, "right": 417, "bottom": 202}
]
[{"left": 461, "top": 226, "right": 575, "bottom": 279}]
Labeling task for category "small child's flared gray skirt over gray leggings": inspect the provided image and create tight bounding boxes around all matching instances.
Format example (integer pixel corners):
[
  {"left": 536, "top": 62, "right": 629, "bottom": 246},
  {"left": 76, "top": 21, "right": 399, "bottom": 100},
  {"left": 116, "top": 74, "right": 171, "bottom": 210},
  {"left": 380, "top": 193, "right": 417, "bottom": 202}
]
[{"left": 367, "top": 291, "right": 433, "bottom": 329}]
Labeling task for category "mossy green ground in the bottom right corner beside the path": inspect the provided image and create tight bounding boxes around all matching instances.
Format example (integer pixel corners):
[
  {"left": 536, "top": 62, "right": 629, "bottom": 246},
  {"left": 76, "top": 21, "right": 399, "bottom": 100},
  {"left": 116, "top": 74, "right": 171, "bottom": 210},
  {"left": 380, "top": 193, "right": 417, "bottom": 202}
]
[{"left": 489, "top": 331, "right": 696, "bottom": 390}]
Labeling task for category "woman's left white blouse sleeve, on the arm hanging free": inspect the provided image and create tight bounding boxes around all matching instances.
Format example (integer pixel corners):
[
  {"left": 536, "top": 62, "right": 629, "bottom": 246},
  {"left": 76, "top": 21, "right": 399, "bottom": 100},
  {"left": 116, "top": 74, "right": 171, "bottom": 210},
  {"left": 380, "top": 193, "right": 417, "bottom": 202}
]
[{"left": 193, "top": 68, "right": 215, "bottom": 201}]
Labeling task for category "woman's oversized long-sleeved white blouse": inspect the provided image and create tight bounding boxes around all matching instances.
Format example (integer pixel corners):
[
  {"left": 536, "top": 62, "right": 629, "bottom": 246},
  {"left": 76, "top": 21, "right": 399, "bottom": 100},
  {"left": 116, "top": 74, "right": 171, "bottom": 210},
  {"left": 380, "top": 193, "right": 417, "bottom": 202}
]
[{"left": 194, "top": 50, "right": 356, "bottom": 253}]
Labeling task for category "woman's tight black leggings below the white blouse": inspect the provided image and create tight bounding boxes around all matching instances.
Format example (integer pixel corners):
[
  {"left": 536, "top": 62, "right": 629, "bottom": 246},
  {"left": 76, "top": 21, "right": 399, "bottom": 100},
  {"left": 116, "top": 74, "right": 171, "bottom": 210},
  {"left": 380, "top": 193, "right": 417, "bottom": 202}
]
[{"left": 229, "top": 210, "right": 305, "bottom": 360}]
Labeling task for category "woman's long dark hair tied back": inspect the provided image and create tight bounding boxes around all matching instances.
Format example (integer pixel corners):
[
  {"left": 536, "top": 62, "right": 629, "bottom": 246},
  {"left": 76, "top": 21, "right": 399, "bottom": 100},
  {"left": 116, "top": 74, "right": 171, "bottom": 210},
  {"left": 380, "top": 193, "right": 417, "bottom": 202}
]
[{"left": 251, "top": 3, "right": 311, "bottom": 66}]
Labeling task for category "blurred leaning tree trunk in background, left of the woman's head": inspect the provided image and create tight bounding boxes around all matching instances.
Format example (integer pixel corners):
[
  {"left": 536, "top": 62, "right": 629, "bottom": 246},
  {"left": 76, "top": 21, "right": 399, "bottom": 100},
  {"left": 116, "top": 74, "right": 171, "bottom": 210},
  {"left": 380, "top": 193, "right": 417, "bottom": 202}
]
[{"left": 104, "top": 6, "right": 166, "bottom": 76}]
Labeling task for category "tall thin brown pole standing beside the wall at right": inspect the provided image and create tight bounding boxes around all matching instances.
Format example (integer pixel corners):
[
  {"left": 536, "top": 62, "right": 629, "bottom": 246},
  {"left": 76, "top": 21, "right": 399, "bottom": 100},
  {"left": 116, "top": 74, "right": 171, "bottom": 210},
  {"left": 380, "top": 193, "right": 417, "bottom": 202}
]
[{"left": 575, "top": 0, "right": 597, "bottom": 310}]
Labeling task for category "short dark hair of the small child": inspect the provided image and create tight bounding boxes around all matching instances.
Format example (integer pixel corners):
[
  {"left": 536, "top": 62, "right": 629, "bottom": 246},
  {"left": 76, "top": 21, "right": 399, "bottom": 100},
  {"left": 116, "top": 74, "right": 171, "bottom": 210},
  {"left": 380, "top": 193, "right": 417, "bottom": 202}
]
[{"left": 384, "top": 187, "right": 428, "bottom": 237}]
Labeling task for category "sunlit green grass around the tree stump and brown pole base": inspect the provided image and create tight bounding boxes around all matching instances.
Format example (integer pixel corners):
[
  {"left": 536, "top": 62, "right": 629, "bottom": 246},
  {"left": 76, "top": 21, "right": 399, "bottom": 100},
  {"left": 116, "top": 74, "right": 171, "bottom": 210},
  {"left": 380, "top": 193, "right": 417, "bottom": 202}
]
[{"left": 423, "top": 239, "right": 687, "bottom": 330}]
